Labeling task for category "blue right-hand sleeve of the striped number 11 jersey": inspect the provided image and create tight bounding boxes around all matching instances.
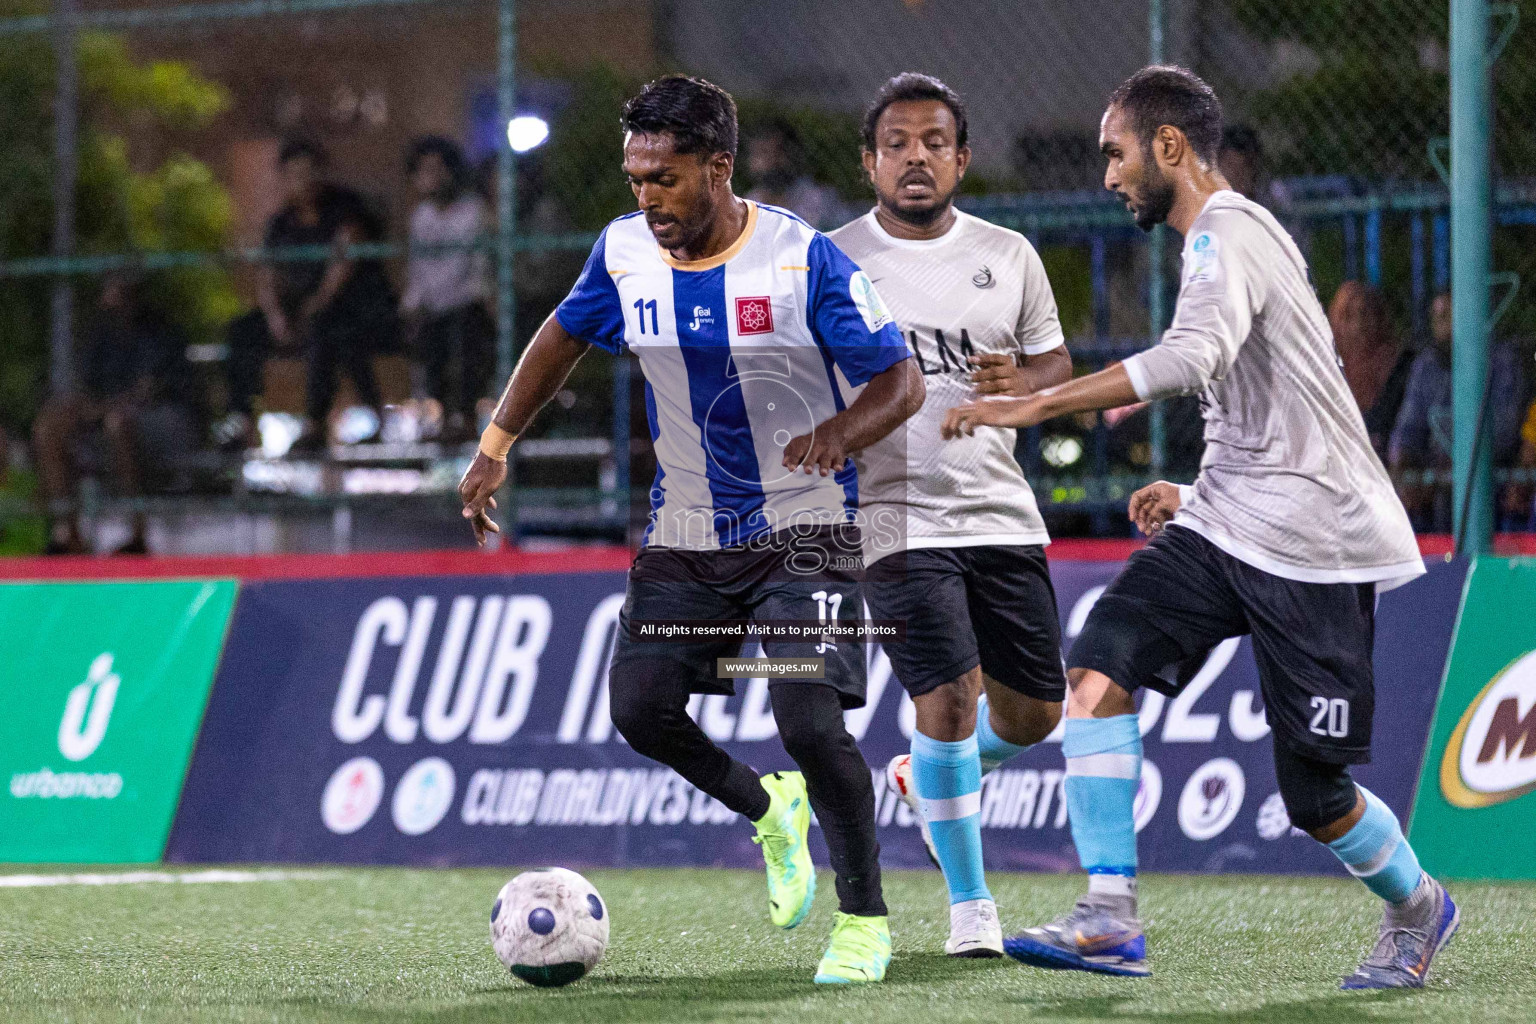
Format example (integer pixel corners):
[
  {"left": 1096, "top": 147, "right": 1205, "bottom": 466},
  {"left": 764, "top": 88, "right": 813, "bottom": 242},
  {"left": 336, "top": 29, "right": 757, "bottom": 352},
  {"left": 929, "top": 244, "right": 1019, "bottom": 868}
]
[{"left": 806, "top": 233, "right": 911, "bottom": 387}]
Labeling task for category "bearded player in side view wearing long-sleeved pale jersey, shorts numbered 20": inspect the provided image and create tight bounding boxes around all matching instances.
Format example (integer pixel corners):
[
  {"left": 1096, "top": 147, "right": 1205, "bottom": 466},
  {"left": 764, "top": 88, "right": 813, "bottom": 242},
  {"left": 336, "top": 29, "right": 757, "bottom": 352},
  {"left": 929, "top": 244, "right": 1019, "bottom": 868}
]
[{"left": 945, "top": 66, "right": 1459, "bottom": 989}]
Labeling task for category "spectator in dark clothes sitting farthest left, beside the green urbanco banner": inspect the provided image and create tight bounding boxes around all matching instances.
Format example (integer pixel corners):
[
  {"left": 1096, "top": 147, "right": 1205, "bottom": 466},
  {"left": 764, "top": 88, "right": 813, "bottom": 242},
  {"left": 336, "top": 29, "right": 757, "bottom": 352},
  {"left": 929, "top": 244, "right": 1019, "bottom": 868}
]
[{"left": 32, "top": 276, "right": 197, "bottom": 554}]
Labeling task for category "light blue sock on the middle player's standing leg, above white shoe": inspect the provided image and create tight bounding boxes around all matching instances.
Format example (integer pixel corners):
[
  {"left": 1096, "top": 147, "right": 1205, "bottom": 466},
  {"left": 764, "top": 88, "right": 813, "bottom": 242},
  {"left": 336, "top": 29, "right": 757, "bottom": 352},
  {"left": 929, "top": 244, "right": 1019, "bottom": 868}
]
[{"left": 912, "top": 732, "right": 992, "bottom": 903}]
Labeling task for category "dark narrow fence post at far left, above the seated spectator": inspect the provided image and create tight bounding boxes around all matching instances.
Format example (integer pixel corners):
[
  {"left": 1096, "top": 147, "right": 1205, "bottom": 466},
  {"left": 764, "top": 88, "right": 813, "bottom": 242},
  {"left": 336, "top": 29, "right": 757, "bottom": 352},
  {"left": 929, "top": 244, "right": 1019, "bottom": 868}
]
[{"left": 48, "top": 0, "right": 80, "bottom": 395}]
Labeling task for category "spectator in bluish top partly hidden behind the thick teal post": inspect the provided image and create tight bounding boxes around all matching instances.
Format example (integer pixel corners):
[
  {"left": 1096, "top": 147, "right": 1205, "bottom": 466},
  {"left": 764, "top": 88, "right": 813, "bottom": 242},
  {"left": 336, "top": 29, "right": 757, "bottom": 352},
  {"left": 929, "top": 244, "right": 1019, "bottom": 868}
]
[{"left": 1389, "top": 293, "right": 1525, "bottom": 533}]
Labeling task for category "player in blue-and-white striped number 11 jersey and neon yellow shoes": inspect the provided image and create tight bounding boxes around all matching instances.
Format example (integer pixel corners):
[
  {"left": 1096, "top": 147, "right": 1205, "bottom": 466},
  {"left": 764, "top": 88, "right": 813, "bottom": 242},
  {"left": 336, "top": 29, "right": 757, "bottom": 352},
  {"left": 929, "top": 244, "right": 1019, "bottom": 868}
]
[{"left": 459, "top": 75, "right": 923, "bottom": 984}]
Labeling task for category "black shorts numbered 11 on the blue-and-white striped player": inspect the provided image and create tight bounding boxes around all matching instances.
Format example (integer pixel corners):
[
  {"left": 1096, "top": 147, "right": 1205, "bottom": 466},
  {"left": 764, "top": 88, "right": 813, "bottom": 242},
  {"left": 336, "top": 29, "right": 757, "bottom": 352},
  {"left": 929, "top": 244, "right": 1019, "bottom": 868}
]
[{"left": 610, "top": 527, "right": 866, "bottom": 708}]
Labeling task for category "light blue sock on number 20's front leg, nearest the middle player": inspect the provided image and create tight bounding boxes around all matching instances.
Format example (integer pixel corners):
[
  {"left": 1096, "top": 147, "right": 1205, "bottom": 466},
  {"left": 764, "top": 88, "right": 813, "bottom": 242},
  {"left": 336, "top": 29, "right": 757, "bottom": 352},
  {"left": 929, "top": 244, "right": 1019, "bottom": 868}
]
[{"left": 1061, "top": 715, "right": 1141, "bottom": 895}]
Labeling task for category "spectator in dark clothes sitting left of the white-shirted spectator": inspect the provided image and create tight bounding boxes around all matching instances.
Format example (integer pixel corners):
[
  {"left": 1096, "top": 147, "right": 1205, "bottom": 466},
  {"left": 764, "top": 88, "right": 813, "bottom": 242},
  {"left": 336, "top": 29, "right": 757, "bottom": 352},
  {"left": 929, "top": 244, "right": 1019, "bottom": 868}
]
[{"left": 227, "top": 141, "right": 398, "bottom": 450}]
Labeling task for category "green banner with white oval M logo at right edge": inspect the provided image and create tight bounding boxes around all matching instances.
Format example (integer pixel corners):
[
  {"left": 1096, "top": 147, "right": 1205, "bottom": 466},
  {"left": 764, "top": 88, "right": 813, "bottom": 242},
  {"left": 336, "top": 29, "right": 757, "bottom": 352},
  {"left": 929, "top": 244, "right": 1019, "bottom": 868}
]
[{"left": 1406, "top": 557, "right": 1536, "bottom": 878}]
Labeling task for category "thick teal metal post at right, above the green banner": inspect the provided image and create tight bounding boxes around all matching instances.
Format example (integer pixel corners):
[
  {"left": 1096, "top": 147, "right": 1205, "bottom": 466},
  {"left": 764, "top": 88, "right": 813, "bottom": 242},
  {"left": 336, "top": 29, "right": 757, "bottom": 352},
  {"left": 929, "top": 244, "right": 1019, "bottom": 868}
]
[{"left": 1450, "top": 0, "right": 1493, "bottom": 554}]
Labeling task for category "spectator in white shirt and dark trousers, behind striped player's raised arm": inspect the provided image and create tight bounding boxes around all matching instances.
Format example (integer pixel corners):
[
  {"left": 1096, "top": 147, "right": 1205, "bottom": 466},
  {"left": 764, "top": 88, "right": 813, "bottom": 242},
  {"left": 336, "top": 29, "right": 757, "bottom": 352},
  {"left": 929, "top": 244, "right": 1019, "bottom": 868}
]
[{"left": 401, "top": 135, "right": 496, "bottom": 444}]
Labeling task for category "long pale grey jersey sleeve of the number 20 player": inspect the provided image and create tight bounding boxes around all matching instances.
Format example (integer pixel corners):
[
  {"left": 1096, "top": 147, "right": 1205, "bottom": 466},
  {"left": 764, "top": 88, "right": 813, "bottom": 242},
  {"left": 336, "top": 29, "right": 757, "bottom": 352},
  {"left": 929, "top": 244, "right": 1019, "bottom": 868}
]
[{"left": 1123, "top": 213, "right": 1278, "bottom": 402}]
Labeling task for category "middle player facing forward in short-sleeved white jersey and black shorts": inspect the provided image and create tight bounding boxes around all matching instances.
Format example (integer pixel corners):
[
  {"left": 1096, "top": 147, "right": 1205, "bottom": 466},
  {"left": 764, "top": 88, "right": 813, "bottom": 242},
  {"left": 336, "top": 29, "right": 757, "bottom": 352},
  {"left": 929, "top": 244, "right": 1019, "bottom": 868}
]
[{"left": 831, "top": 72, "right": 1072, "bottom": 956}]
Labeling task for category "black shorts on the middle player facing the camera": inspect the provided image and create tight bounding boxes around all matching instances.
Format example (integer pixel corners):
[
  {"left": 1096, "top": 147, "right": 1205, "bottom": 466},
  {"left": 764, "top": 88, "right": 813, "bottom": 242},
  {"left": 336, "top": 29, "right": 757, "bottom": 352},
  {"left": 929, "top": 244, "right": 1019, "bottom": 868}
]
[{"left": 865, "top": 543, "right": 1066, "bottom": 702}]
